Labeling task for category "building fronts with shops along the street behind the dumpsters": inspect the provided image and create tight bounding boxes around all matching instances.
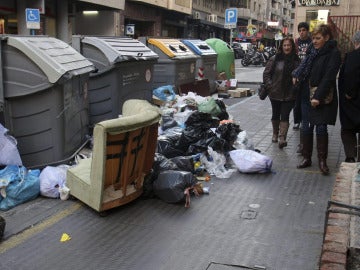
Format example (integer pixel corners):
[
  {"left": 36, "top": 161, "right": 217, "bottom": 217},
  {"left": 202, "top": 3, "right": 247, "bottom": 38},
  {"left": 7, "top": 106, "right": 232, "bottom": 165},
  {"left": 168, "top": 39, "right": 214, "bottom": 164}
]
[{"left": 0, "top": 0, "right": 304, "bottom": 42}]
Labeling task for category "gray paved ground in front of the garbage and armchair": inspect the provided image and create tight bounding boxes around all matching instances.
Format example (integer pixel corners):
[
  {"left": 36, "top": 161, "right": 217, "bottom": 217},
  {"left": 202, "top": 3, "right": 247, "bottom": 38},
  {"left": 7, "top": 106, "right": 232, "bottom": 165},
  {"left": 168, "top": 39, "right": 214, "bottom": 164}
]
[{"left": 0, "top": 89, "right": 358, "bottom": 270}]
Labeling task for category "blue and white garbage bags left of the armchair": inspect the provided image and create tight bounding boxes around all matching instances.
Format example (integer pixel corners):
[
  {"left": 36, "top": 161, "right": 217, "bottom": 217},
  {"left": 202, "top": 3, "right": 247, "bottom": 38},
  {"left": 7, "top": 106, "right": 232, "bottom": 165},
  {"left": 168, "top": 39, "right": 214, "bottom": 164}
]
[{"left": 0, "top": 124, "right": 69, "bottom": 212}]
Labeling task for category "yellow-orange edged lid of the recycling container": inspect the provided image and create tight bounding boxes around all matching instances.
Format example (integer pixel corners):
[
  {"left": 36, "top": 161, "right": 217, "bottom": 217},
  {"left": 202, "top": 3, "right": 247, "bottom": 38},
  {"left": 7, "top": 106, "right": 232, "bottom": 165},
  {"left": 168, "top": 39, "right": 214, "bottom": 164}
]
[{"left": 148, "top": 38, "right": 198, "bottom": 58}]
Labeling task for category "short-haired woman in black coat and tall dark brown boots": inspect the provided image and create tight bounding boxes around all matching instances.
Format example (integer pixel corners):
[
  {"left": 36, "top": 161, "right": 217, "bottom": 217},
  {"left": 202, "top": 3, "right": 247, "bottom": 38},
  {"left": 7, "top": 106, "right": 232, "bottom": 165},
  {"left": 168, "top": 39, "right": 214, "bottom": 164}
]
[{"left": 293, "top": 24, "right": 341, "bottom": 175}]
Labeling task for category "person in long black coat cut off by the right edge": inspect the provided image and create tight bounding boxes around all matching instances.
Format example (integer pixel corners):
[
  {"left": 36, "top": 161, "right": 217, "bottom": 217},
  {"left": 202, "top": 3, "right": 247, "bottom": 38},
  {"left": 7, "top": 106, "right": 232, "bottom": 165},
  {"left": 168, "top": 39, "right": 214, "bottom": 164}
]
[{"left": 338, "top": 31, "right": 360, "bottom": 162}]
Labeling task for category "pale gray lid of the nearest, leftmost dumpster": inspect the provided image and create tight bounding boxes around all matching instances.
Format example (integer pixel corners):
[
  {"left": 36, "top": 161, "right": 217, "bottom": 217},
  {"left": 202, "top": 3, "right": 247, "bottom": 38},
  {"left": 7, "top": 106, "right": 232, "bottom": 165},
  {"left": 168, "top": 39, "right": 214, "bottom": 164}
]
[{"left": 7, "top": 36, "right": 95, "bottom": 83}]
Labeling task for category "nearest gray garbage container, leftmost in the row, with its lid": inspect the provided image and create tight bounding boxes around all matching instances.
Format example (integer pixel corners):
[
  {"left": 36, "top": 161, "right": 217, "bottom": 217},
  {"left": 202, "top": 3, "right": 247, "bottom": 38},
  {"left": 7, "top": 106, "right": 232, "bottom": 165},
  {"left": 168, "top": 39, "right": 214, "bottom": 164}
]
[{"left": 0, "top": 36, "right": 94, "bottom": 167}]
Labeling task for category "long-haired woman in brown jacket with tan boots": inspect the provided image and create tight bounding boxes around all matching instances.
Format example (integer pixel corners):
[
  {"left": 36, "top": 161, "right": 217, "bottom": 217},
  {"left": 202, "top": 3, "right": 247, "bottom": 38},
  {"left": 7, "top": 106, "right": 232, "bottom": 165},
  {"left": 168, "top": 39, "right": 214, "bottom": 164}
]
[{"left": 263, "top": 37, "right": 300, "bottom": 148}]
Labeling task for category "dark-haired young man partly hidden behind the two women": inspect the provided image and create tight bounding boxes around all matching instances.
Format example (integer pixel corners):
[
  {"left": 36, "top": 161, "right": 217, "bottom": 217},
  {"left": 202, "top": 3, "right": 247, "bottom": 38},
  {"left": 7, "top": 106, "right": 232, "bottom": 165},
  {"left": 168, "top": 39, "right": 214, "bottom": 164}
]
[{"left": 293, "top": 22, "right": 311, "bottom": 153}]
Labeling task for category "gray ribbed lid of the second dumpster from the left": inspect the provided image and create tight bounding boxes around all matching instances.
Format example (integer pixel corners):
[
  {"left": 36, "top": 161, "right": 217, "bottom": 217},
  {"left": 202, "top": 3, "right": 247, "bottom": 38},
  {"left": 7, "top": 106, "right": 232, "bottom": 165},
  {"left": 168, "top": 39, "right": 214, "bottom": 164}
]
[{"left": 81, "top": 36, "right": 159, "bottom": 63}]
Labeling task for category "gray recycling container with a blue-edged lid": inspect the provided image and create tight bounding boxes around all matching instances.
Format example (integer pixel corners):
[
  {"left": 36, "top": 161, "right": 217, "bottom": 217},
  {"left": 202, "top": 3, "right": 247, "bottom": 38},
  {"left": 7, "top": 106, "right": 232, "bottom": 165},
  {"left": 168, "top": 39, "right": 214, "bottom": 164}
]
[{"left": 181, "top": 39, "right": 217, "bottom": 94}]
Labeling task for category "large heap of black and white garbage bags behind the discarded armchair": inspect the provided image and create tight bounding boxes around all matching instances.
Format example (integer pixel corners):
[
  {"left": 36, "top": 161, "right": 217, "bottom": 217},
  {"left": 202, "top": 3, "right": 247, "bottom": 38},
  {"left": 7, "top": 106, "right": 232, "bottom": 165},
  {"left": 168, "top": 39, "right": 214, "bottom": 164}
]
[{"left": 144, "top": 89, "right": 272, "bottom": 206}]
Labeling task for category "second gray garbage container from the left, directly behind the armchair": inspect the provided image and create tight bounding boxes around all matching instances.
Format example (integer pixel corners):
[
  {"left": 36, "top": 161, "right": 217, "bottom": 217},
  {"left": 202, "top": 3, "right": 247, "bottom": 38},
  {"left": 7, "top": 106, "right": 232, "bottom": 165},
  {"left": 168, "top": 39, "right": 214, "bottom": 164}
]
[{"left": 72, "top": 36, "right": 159, "bottom": 126}]
